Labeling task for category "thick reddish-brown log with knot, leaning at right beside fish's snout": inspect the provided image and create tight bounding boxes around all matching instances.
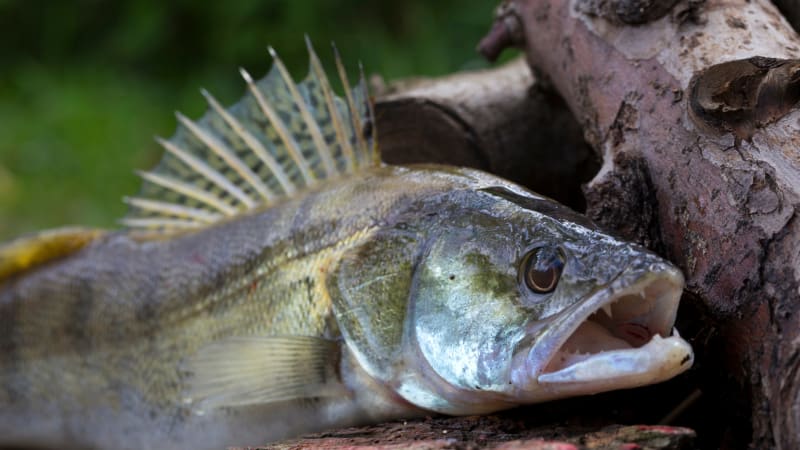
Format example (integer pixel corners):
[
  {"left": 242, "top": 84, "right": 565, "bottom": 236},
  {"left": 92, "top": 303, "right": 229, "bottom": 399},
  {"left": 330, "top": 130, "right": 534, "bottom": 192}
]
[{"left": 482, "top": 0, "right": 800, "bottom": 449}]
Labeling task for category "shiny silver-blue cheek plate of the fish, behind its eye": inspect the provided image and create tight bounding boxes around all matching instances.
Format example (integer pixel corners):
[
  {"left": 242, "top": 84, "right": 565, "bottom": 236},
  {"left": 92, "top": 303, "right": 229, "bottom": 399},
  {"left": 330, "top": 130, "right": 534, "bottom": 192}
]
[{"left": 409, "top": 243, "right": 528, "bottom": 393}]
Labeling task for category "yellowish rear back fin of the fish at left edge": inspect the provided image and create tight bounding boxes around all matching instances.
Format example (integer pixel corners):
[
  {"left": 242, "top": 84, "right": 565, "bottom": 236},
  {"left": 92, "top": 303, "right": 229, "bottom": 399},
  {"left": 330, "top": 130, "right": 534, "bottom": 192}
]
[{"left": 0, "top": 227, "right": 105, "bottom": 283}]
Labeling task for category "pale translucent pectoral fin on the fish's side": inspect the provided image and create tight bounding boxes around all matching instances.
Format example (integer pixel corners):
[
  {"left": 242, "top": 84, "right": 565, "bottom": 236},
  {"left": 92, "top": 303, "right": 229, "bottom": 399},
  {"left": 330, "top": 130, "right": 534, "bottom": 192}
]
[{"left": 185, "top": 336, "right": 347, "bottom": 409}]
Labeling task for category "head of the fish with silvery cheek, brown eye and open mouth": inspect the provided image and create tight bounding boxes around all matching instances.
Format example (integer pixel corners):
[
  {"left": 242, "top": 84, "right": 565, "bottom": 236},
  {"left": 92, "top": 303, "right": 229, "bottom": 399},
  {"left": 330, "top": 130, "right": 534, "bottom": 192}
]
[{"left": 396, "top": 187, "right": 693, "bottom": 414}]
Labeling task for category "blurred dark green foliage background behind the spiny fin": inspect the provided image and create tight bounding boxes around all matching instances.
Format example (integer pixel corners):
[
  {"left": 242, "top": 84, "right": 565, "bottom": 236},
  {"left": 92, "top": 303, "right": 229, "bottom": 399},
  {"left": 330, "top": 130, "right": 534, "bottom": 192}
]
[{"left": 0, "top": 0, "right": 512, "bottom": 241}]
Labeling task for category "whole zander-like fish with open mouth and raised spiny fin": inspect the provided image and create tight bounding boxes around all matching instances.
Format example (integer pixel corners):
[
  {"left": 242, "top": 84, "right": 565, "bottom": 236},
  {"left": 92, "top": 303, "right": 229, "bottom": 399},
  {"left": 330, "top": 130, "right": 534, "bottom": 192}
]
[{"left": 0, "top": 42, "right": 694, "bottom": 449}]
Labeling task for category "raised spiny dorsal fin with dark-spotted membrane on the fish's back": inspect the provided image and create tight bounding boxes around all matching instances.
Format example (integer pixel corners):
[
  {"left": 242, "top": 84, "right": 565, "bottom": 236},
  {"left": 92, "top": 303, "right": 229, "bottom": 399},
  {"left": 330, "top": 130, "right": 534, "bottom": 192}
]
[{"left": 122, "top": 37, "right": 380, "bottom": 230}]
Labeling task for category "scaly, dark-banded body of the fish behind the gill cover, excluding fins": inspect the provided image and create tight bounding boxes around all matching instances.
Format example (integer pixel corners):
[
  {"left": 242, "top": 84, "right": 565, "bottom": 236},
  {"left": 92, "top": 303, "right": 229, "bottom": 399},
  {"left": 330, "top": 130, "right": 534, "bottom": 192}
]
[{"left": 0, "top": 167, "right": 469, "bottom": 448}]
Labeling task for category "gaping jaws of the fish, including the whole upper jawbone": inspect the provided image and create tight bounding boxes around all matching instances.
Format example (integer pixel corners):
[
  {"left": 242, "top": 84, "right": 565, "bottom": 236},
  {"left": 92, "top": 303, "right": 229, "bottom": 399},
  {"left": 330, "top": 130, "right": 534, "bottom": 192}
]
[{"left": 511, "top": 263, "right": 694, "bottom": 402}]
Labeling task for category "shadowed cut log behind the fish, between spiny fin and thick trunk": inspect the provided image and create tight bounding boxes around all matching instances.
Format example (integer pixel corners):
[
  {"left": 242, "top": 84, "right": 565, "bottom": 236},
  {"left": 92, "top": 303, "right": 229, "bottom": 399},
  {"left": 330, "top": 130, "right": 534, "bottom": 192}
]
[{"left": 372, "top": 58, "right": 599, "bottom": 210}]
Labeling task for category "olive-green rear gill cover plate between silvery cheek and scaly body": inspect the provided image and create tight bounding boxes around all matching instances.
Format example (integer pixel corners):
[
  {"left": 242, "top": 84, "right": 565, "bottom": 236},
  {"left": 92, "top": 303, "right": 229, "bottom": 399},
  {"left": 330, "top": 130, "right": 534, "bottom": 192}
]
[{"left": 327, "top": 230, "right": 419, "bottom": 382}]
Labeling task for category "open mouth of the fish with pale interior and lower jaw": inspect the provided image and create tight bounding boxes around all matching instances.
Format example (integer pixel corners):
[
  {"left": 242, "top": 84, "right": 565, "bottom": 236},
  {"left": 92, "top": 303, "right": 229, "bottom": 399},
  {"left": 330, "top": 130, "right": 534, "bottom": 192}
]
[{"left": 537, "top": 270, "right": 694, "bottom": 395}]
